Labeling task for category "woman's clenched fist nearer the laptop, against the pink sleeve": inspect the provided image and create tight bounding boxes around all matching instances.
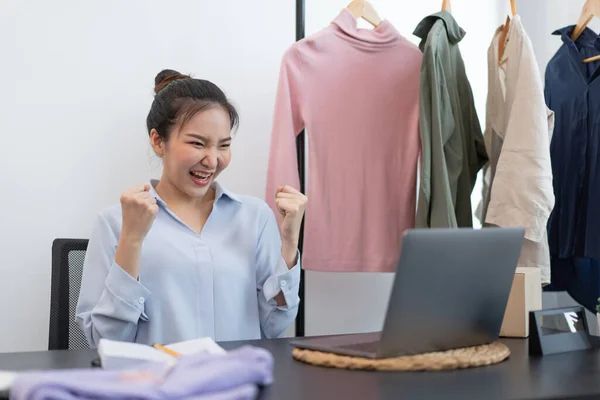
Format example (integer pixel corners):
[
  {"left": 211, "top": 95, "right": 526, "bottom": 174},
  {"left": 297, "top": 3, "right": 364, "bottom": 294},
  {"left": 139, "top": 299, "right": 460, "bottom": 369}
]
[{"left": 275, "top": 185, "right": 308, "bottom": 249}]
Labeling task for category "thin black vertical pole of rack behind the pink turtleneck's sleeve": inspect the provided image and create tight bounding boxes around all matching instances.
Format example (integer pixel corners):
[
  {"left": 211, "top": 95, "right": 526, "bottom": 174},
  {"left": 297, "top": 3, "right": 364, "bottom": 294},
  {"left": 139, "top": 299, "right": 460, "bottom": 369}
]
[{"left": 296, "top": 0, "right": 306, "bottom": 337}]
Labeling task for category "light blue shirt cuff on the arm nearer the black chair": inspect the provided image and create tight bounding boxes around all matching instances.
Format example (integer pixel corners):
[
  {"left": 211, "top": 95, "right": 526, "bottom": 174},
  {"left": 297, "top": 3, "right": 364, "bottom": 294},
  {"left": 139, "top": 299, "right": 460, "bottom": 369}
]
[{"left": 105, "top": 262, "right": 150, "bottom": 321}]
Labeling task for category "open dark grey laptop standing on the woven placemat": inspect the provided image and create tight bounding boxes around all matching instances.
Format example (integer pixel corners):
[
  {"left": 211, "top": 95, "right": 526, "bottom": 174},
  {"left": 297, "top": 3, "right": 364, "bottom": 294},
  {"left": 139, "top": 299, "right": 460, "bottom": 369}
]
[{"left": 291, "top": 228, "right": 525, "bottom": 358}]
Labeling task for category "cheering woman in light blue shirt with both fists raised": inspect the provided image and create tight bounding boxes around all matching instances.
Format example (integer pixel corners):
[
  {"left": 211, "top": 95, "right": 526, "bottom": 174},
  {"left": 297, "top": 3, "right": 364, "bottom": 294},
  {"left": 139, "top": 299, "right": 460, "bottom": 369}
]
[{"left": 76, "top": 70, "right": 307, "bottom": 347}]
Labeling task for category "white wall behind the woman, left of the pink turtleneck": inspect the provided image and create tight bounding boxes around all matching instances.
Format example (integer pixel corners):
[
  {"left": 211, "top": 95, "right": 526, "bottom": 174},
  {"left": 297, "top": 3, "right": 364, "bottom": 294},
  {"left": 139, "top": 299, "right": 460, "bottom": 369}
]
[{"left": 0, "top": 0, "right": 295, "bottom": 352}]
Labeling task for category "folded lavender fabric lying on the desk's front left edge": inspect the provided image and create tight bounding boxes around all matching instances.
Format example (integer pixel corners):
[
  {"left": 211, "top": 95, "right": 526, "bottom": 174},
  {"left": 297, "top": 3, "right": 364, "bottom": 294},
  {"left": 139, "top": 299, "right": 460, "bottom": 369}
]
[{"left": 10, "top": 346, "right": 273, "bottom": 400}]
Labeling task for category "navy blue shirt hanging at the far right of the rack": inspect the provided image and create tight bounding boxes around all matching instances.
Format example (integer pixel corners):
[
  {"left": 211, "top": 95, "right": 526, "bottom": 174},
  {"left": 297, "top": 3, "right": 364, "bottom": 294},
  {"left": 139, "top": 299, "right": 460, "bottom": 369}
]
[{"left": 545, "top": 26, "right": 600, "bottom": 259}]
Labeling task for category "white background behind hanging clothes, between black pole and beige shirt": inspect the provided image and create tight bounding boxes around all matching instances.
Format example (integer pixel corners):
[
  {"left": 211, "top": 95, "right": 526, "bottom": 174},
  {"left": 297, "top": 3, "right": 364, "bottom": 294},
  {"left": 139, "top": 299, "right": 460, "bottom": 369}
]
[{"left": 305, "top": 0, "right": 508, "bottom": 335}]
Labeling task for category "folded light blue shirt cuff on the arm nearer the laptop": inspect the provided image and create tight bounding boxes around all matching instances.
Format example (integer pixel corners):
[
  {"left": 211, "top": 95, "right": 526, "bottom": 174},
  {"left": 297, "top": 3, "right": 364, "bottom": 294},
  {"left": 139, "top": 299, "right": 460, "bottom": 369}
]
[{"left": 263, "top": 251, "right": 301, "bottom": 311}]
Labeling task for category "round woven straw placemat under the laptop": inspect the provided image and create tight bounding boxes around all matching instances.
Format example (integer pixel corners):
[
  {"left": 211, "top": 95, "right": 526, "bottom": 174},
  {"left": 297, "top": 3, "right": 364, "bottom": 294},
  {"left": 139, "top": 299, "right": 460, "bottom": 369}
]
[{"left": 292, "top": 342, "right": 510, "bottom": 371}]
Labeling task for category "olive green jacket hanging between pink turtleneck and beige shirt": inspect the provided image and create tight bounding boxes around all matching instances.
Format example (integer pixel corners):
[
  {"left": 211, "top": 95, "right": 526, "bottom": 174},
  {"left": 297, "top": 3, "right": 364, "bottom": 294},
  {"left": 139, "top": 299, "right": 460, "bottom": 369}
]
[{"left": 414, "top": 11, "right": 488, "bottom": 228}]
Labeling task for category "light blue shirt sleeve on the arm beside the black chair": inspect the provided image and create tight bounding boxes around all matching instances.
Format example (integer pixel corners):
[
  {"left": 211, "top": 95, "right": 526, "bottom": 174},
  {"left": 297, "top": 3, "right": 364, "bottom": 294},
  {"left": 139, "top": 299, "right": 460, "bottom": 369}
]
[{"left": 76, "top": 214, "right": 150, "bottom": 348}]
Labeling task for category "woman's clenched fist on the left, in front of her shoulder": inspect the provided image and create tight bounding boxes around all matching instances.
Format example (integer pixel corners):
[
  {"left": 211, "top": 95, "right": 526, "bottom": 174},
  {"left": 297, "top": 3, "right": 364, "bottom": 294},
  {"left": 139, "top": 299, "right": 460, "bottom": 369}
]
[{"left": 121, "top": 184, "right": 158, "bottom": 244}]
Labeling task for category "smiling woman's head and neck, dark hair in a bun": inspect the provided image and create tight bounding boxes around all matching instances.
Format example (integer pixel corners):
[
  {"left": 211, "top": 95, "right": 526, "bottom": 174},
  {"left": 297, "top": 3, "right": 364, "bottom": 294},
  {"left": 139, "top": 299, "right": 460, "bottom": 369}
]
[{"left": 146, "top": 70, "right": 239, "bottom": 222}]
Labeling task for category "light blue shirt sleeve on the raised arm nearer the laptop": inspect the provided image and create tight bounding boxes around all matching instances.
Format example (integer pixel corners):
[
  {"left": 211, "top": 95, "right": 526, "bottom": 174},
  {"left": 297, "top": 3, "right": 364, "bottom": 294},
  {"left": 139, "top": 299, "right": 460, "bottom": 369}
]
[{"left": 256, "top": 210, "right": 301, "bottom": 338}]
